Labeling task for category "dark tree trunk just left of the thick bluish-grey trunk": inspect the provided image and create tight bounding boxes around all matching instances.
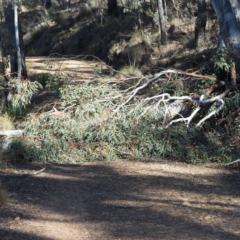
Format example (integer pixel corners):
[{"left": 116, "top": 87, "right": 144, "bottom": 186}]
[{"left": 195, "top": 0, "right": 207, "bottom": 47}]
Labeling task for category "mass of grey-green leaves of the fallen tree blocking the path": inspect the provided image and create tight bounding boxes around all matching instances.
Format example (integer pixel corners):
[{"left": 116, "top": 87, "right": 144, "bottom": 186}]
[{"left": 8, "top": 79, "right": 234, "bottom": 164}]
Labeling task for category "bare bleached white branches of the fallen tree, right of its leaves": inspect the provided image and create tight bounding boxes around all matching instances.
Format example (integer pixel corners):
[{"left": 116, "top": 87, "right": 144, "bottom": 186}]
[{"left": 113, "top": 69, "right": 227, "bottom": 127}]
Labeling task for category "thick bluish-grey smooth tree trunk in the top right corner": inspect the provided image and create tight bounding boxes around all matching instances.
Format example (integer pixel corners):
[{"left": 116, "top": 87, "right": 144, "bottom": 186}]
[{"left": 211, "top": 0, "right": 240, "bottom": 49}]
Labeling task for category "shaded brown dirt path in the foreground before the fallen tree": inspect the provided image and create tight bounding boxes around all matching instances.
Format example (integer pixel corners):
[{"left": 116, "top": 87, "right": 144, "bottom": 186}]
[{"left": 0, "top": 161, "right": 240, "bottom": 240}]
